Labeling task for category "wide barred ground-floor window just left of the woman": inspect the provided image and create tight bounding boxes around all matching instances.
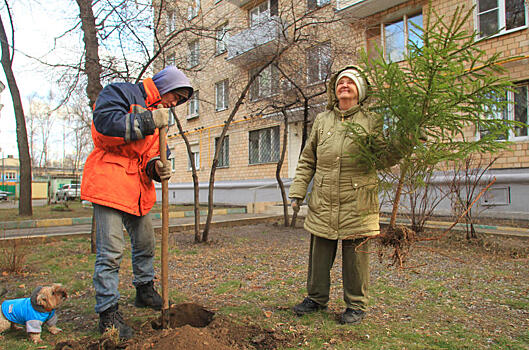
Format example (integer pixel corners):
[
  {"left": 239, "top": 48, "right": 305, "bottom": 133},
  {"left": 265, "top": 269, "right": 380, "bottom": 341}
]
[{"left": 248, "top": 126, "right": 279, "bottom": 164}]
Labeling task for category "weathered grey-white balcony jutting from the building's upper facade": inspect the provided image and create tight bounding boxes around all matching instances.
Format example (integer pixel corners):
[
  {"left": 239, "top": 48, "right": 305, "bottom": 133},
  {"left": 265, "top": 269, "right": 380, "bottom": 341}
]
[{"left": 226, "top": 16, "right": 284, "bottom": 65}]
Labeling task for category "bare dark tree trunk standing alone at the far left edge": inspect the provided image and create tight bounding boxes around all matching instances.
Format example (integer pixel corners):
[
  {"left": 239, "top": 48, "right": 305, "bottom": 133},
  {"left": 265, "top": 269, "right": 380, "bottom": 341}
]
[{"left": 0, "top": 13, "right": 33, "bottom": 216}]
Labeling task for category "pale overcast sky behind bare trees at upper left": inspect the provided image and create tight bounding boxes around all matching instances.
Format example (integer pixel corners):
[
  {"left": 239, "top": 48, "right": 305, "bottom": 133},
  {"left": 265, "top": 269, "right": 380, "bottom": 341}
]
[{"left": 0, "top": 0, "right": 78, "bottom": 158}]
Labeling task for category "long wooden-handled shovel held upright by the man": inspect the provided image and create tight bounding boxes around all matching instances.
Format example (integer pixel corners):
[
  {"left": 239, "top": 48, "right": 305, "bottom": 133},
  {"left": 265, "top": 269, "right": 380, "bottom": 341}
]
[{"left": 158, "top": 127, "right": 169, "bottom": 328}]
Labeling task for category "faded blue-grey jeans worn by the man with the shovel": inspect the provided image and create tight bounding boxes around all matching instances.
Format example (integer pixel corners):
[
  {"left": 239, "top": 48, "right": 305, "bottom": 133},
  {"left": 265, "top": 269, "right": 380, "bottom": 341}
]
[{"left": 93, "top": 204, "right": 155, "bottom": 313}]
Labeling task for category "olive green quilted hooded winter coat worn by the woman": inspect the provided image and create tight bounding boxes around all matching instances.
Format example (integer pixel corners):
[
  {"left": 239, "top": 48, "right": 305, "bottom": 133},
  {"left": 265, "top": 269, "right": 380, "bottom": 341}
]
[{"left": 289, "top": 67, "right": 382, "bottom": 240}]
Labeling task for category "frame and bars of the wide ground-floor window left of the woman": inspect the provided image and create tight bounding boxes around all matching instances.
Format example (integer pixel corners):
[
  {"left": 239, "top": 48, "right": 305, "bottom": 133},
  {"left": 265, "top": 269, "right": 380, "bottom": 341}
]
[{"left": 248, "top": 125, "right": 281, "bottom": 165}]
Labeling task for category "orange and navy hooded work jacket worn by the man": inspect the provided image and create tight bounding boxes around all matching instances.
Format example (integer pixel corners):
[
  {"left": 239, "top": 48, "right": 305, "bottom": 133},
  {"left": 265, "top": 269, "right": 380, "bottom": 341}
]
[{"left": 81, "top": 78, "right": 165, "bottom": 216}]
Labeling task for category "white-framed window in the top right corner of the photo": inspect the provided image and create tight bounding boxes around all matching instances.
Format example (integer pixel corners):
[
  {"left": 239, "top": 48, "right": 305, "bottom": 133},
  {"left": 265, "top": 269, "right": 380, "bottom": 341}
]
[{"left": 476, "top": 0, "right": 527, "bottom": 36}]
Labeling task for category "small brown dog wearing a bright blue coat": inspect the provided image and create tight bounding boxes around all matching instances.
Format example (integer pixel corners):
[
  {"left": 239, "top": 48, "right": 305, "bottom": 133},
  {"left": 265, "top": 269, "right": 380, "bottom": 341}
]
[{"left": 0, "top": 283, "right": 68, "bottom": 343}]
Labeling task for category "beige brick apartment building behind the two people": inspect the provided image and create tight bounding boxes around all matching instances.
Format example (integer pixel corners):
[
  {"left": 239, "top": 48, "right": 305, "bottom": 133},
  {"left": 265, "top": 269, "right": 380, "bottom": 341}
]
[{"left": 155, "top": 0, "right": 529, "bottom": 213}]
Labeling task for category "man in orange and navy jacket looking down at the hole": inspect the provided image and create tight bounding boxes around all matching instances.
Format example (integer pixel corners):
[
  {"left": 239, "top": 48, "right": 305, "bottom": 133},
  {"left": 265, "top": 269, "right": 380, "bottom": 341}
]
[{"left": 81, "top": 66, "right": 193, "bottom": 339}]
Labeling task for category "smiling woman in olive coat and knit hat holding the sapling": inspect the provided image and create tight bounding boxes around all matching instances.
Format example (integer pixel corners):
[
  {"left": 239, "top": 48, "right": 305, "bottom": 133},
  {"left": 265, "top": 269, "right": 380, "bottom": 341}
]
[{"left": 289, "top": 66, "right": 390, "bottom": 323}]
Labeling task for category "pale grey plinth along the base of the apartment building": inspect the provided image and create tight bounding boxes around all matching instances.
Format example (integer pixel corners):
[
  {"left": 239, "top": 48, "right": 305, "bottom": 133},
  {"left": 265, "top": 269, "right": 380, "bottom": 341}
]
[{"left": 156, "top": 169, "right": 529, "bottom": 220}]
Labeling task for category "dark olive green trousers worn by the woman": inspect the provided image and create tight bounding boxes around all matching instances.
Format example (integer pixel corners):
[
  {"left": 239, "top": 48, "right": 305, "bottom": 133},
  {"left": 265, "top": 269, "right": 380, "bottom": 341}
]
[{"left": 307, "top": 235, "right": 369, "bottom": 311}]
